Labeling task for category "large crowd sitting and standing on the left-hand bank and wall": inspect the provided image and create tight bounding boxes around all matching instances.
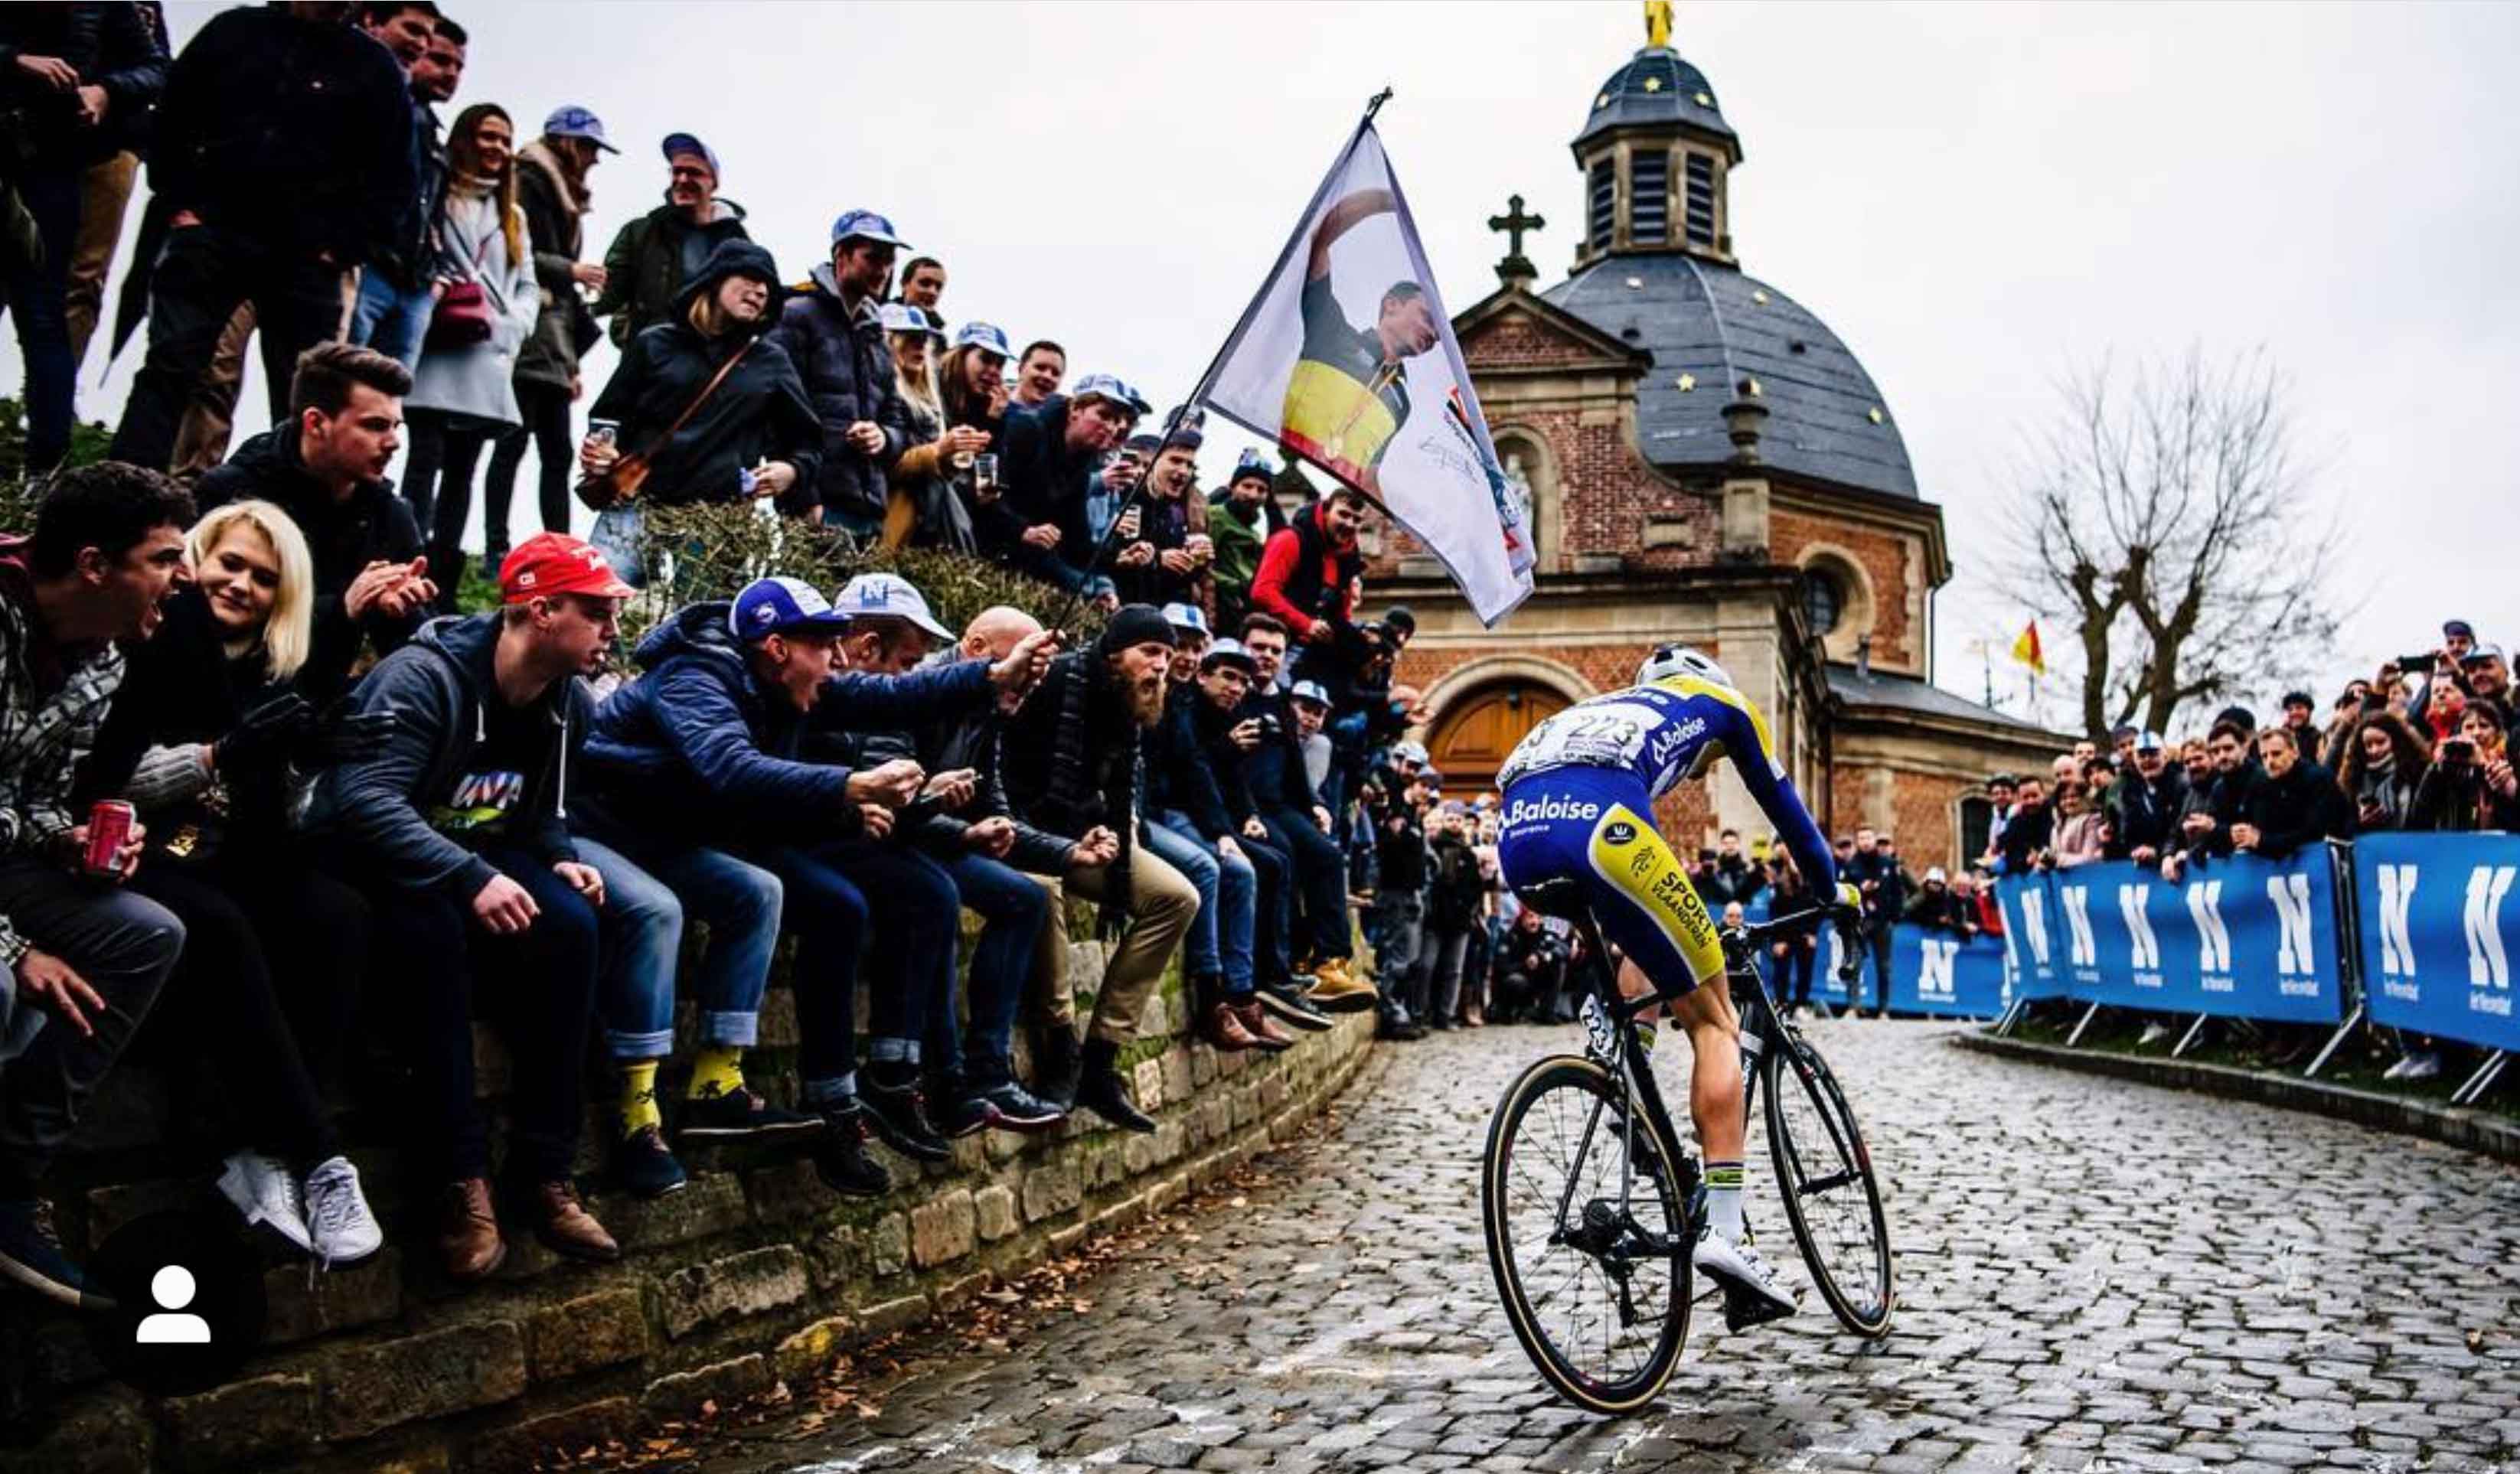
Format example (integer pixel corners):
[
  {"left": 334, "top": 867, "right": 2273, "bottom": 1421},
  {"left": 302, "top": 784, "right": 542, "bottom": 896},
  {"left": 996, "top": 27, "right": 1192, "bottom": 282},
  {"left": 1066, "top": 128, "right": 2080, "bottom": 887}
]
[{"left": 0, "top": 0, "right": 1532, "bottom": 1303}]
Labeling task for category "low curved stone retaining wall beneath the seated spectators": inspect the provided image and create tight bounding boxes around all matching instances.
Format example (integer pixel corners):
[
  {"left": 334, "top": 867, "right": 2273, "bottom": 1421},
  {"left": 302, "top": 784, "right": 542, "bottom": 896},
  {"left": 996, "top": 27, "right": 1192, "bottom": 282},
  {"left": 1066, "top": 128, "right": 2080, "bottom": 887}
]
[{"left": 0, "top": 917, "right": 1373, "bottom": 1474}]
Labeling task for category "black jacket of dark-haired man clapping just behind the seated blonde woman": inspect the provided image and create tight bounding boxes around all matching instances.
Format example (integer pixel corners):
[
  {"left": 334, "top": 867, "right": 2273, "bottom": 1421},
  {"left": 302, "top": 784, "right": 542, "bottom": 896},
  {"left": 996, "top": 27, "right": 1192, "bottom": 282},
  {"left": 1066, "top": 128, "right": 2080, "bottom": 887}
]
[{"left": 191, "top": 426, "right": 426, "bottom": 703}]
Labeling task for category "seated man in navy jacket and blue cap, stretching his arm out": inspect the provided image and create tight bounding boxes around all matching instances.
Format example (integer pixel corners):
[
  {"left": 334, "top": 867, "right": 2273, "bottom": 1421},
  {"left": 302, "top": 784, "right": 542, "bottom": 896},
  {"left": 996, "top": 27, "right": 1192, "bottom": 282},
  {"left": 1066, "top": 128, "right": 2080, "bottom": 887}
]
[{"left": 582, "top": 577, "right": 1030, "bottom": 1197}]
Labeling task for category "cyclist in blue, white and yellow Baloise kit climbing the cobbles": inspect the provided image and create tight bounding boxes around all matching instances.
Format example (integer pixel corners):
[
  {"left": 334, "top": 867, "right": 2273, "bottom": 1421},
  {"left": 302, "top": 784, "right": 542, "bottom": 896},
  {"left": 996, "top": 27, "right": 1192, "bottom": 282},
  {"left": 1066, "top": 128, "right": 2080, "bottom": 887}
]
[{"left": 1497, "top": 645, "right": 1857, "bottom": 1313}]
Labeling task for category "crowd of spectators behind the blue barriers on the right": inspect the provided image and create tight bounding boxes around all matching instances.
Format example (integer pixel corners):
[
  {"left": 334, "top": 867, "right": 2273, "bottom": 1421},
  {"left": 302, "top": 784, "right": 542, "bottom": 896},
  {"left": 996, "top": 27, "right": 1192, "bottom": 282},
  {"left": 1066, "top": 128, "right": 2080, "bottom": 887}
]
[{"left": 1983, "top": 620, "right": 2520, "bottom": 1078}]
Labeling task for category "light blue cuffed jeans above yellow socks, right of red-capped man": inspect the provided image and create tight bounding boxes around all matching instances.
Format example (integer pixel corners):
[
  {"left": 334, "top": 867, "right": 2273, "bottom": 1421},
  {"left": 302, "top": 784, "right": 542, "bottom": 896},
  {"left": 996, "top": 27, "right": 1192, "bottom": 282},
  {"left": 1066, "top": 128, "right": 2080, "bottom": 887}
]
[{"left": 577, "top": 834, "right": 784, "bottom": 1061}]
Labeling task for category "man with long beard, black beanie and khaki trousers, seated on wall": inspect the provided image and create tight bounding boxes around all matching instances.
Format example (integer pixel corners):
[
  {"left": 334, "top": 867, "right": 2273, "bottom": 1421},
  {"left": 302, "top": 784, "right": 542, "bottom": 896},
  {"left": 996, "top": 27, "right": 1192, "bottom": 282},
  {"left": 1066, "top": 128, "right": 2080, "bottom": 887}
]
[{"left": 1000, "top": 605, "right": 1200, "bottom": 1131}]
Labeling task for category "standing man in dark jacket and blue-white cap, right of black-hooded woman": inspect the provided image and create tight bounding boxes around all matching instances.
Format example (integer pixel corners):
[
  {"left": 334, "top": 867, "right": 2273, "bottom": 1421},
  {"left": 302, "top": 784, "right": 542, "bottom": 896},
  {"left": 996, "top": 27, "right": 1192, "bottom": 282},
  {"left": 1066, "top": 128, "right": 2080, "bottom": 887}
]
[{"left": 779, "top": 209, "right": 909, "bottom": 536}]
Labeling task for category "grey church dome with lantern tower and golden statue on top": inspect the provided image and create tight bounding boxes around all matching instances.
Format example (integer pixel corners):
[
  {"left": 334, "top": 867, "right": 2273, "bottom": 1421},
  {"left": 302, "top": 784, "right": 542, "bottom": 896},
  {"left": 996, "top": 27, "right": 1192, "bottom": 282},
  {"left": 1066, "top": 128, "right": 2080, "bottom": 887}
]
[{"left": 1542, "top": 5, "right": 1918, "bottom": 497}]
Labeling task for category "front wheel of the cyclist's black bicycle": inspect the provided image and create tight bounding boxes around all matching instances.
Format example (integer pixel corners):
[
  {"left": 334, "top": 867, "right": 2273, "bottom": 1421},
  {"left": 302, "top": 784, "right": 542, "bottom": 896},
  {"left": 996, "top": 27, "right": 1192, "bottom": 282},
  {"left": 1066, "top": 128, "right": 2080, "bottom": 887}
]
[{"left": 1767, "top": 1035, "right": 1895, "bottom": 1335}]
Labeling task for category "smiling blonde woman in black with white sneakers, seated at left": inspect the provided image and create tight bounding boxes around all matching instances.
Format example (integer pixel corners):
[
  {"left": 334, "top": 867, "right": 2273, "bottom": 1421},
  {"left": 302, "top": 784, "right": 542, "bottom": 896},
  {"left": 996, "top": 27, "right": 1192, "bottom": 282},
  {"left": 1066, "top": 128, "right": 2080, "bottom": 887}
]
[{"left": 78, "top": 501, "right": 390, "bottom": 1265}]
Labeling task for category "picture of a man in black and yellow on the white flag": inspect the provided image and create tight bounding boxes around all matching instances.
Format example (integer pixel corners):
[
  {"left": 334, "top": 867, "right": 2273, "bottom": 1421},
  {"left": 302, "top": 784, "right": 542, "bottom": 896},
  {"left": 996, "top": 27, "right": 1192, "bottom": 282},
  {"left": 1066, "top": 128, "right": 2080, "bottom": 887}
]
[{"left": 1283, "top": 189, "right": 1441, "bottom": 494}]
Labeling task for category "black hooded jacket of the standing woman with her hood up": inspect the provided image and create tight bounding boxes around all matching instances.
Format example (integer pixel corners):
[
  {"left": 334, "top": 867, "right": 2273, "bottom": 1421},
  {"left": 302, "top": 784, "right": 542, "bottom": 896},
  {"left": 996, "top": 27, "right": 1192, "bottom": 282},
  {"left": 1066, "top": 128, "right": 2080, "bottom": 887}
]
[{"left": 589, "top": 240, "right": 821, "bottom": 511}]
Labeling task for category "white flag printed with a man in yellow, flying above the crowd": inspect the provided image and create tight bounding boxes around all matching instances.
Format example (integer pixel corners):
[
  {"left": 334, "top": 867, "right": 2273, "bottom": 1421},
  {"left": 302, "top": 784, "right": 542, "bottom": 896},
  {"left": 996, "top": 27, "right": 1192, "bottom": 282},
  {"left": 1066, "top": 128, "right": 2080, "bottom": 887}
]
[{"left": 1202, "top": 123, "right": 1533, "bottom": 624}]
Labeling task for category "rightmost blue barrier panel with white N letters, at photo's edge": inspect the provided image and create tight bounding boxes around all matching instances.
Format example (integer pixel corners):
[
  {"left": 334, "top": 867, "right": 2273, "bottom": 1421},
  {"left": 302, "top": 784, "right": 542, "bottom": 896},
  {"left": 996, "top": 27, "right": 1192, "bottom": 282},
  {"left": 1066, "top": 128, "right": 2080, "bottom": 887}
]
[{"left": 2354, "top": 834, "right": 2520, "bottom": 1051}]
